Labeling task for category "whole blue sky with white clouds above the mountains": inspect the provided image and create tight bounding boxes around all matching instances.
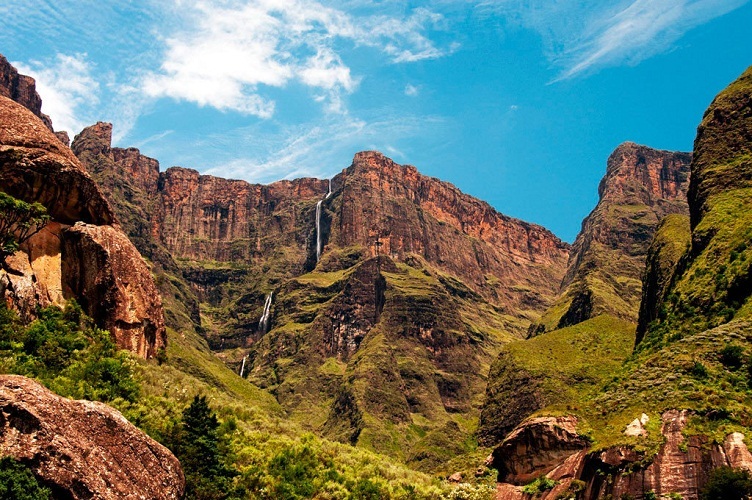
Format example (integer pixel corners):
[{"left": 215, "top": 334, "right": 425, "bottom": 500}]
[{"left": 0, "top": 0, "right": 752, "bottom": 241}]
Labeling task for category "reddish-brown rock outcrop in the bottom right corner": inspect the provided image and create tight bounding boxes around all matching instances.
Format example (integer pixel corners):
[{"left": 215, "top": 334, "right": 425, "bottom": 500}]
[{"left": 493, "top": 410, "right": 752, "bottom": 500}]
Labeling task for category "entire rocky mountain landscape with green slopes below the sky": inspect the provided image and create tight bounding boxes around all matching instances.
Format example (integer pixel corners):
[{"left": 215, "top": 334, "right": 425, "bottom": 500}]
[{"left": 0, "top": 49, "right": 752, "bottom": 500}]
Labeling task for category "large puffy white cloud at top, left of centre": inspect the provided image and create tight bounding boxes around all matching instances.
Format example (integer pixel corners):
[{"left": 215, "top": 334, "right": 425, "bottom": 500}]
[{"left": 142, "top": 0, "right": 457, "bottom": 118}]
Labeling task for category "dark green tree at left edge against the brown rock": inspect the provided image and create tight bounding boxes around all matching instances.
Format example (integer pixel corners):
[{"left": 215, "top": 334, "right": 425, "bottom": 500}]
[{"left": 0, "top": 191, "right": 50, "bottom": 267}]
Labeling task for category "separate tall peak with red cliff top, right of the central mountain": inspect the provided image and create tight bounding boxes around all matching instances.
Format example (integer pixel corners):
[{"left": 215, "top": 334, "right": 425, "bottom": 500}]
[{"left": 537, "top": 143, "right": 691, "bottom": 333}]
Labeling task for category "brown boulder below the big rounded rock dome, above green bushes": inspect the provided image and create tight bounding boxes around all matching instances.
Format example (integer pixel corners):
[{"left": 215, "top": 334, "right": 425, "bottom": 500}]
[{"left": 62, "top": 222, "right": 167, "bottom": 358}]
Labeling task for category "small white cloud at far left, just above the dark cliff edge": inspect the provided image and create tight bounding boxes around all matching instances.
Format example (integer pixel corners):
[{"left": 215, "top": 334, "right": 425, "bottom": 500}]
[{"left": 13, "top": 54, "right": 99, "bottom": 133}]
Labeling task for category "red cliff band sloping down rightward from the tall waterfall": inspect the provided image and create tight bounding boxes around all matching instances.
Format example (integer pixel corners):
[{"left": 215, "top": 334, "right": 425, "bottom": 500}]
[{"left": 329, "top": 151, "right": 569, "bottom": 311}]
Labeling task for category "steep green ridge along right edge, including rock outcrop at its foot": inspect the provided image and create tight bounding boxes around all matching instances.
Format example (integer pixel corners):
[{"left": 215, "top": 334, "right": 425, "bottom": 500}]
[{"left": 484, "top": 64, "right": 752, "bottom": 499}]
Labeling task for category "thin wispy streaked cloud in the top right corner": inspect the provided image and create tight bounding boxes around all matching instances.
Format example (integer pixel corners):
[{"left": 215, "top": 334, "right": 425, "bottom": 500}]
[{"left": 476, "top": 0, "right": 749, "bottom": 81}]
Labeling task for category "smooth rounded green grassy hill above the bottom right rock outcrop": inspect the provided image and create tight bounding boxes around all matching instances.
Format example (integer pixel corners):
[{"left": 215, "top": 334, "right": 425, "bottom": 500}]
[{"left": 479, "top": 315, "right": 639, "bottom": 445}]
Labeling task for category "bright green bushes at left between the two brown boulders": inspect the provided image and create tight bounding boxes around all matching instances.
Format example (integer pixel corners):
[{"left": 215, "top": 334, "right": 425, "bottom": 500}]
[{"left": 0, "top": 301, "right": 139, "bottom": 401}]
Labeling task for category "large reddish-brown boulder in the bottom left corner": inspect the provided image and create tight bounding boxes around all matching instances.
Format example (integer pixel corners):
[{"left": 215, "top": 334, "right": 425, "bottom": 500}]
[{"left": 0, "top": 375, "right": 185, "bottom": 500}]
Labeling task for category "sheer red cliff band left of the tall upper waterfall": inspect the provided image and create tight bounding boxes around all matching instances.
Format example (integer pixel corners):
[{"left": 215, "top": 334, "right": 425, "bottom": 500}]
[{"left": 154, "top": 167, "right": 328, "bottom": 265}]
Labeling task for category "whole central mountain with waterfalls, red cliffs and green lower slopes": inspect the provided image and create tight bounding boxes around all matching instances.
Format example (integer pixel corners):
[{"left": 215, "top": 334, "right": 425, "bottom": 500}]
[{"left": 73, "top": 130, "right": 569, "bottom": 468}]
